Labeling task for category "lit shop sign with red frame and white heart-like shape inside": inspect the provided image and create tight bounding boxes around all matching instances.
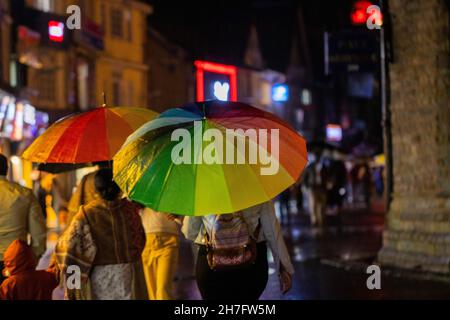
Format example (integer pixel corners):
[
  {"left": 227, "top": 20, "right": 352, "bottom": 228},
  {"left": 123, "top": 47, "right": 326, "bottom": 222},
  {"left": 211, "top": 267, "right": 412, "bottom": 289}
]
[{"left": 194, "top": 60, "right": 237, "bottom": 101}]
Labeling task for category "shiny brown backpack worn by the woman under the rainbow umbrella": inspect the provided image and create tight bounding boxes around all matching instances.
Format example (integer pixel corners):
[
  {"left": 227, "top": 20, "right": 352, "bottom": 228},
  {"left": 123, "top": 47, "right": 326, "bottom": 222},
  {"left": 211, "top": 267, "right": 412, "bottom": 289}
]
[{"left": 205, "top": 212, "right": 260, "bottom": 270}]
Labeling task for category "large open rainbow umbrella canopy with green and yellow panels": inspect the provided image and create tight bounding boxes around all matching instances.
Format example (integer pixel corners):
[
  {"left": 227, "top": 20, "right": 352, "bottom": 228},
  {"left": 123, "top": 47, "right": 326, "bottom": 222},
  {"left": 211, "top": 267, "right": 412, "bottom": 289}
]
[{"left": 113, "top": 101, "right": 307, "bottom": 215}]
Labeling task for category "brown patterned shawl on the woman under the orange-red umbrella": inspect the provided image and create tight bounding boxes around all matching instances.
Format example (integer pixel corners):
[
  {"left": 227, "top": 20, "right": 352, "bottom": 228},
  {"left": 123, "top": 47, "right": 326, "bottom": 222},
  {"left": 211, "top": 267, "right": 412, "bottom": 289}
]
[{"left": 55, "top": 199, "right": 145, "bottom": 300}]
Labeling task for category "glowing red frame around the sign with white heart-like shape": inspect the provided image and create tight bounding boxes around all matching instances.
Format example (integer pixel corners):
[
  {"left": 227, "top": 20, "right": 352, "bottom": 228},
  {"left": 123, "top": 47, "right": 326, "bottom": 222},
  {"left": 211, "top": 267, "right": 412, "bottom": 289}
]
[{"left": 194, "top": 60, "right": 237, "bottom": 101}]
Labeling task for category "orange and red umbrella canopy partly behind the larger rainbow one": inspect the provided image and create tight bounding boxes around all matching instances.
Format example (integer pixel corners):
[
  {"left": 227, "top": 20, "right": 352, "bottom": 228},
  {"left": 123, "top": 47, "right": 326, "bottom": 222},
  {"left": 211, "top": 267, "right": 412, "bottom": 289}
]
[{"left": 22, "top": 107, "right": 157, "bottom": 165}]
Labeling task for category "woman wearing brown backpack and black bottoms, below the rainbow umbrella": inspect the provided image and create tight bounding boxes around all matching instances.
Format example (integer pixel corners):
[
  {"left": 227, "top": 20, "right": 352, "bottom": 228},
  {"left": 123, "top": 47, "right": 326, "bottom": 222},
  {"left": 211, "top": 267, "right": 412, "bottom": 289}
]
[{"left": 183, "top": 202, "right": 294, "bottom": 300}]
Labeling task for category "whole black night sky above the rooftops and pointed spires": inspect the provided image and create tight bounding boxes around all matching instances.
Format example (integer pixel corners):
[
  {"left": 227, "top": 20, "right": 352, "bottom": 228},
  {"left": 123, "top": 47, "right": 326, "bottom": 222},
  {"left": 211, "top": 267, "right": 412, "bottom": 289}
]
[{"left": 146, "top": 0, "right": 353, "bottom": 73}]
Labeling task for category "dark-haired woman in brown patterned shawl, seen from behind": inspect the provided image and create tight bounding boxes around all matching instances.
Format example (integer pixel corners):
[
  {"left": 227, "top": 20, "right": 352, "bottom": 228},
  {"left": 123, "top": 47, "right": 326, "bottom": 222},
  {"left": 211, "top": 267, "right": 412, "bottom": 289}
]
[{"left": 55, "top": 169, "right": 148, "bottom": 300}]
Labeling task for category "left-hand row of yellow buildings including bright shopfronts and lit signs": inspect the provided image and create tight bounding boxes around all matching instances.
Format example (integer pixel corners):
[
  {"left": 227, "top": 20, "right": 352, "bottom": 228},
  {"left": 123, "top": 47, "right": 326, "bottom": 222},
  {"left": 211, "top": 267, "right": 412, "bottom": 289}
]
[{"left": 0, "top": 0, "right": 152, "bottom": 186}]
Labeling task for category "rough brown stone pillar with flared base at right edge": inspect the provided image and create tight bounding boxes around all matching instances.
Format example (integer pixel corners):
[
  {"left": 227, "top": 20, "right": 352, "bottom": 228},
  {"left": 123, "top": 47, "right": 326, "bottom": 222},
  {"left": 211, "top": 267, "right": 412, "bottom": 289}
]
[{"left": 378, "top": 0, "right": 450, "bottom": 273}]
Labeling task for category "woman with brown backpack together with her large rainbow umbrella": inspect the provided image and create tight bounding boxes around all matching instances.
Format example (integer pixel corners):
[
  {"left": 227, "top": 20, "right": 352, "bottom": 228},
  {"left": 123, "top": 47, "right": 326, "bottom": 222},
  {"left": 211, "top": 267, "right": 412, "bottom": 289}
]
[{"left": 113, "top": 101, "right": 307, "bottom": 299}]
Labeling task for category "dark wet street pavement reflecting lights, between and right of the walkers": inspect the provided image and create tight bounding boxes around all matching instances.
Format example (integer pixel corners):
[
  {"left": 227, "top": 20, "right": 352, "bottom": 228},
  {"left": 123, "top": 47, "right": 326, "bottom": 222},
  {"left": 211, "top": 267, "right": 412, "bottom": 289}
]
[{"left": 40, "top": 202, "right": 450, "bottom": 300}]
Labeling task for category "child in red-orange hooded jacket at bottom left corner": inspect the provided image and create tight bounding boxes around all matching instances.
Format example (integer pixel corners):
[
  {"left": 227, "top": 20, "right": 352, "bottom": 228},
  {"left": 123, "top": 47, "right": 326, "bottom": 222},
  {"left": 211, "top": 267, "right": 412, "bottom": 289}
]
[{"left": 0, "top": 240, "right": 58, "bottom": 300}]
